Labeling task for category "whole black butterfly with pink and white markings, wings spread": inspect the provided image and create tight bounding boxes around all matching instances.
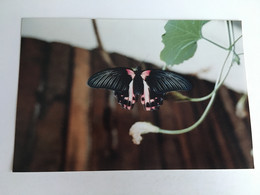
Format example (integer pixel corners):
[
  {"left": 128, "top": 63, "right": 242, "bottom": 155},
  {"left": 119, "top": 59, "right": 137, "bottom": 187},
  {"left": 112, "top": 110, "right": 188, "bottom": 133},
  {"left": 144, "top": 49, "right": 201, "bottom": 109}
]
[{"left": 88, "top": 67, "right": 191, "bottom": 111}]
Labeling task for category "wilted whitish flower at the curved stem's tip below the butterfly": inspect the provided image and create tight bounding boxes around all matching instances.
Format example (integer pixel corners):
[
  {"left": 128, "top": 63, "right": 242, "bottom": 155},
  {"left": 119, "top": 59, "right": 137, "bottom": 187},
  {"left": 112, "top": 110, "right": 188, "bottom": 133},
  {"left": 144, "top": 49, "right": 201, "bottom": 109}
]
[{"left": 129, "top": 122, "right": 159, "bottom": 145}]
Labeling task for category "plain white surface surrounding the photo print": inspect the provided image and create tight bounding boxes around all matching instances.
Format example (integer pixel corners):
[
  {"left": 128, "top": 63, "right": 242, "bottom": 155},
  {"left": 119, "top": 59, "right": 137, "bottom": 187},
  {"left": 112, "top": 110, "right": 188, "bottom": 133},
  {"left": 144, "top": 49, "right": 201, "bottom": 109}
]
[{"left": 0, "top": 0, "right": 260, "bottom": 194}]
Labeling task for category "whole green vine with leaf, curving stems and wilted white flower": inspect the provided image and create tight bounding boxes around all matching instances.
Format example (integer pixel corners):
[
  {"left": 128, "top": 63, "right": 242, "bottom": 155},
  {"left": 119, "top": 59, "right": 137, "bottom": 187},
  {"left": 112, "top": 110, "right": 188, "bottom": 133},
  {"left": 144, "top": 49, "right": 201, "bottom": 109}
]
[{"left": 129, "top": 21, "right": 245, "bottom": 144}]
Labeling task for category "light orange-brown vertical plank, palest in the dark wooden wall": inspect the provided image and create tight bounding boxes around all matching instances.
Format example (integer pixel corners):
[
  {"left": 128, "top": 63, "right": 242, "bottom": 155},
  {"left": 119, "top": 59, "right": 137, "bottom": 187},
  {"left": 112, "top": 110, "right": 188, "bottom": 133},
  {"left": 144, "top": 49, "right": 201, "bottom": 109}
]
[{"left": 65, "top": 48, "right": 90, "bottom": 171}]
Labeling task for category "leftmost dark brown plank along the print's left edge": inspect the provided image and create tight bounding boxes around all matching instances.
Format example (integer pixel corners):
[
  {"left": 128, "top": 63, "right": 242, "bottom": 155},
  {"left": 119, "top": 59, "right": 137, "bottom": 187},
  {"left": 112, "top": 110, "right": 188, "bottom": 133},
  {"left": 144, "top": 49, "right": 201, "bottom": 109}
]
[{"left": 13, "top": 38, "right": 49, "bottom": 171}]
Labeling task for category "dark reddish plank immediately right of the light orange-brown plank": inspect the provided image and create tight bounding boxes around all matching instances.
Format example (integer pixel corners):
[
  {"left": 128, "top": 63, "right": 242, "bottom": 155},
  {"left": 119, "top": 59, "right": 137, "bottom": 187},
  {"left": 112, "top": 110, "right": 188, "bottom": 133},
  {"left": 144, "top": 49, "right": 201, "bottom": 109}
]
[{"left": 88, "top": 50, "right": 110, "bottom": 170}]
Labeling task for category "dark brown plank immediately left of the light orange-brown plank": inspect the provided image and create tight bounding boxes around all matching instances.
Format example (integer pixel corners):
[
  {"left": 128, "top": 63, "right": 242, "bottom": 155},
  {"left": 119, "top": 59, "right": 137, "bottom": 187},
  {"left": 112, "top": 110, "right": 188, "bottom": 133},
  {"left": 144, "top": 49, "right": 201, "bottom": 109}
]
[{"left": 31, "top": 43, "right": 72, "bottom": 171}]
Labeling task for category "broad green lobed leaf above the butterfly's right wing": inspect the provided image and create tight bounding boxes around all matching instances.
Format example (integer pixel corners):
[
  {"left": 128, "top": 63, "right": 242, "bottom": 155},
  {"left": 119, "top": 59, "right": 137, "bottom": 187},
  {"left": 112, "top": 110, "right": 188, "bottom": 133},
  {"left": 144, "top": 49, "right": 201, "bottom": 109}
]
[{"left": 160, "top": 20, "right": 208, "bottom": 65}]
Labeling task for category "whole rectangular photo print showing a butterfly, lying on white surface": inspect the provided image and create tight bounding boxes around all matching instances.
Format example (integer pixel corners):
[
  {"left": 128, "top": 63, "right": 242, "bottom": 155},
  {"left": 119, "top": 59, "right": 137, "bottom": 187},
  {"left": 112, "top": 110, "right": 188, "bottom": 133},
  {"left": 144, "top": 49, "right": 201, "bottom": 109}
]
[{"left": 13, "top": 18, "right": 254, "bottom": 172}]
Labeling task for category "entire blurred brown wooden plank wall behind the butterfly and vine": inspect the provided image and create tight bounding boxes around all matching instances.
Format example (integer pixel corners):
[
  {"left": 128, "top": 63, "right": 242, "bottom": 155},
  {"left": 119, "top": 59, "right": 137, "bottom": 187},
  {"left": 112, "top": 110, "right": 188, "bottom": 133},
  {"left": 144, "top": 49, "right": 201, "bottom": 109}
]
[{"left": 13, "top": 38, "right": 253, "bottom": 171}]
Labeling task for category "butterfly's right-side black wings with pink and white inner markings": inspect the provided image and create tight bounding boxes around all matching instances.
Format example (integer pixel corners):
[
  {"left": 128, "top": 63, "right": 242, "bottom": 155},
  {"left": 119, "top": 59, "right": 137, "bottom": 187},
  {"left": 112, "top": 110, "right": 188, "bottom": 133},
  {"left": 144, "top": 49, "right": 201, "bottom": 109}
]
[{"left": 141, "top": 69, "right": 192, "bottom": 111}]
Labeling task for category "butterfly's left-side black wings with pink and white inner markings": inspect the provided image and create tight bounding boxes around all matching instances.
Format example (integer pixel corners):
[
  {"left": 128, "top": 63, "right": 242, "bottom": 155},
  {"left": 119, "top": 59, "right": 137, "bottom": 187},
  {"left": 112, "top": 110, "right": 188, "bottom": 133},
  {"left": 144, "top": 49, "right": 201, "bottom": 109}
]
[{"left": 88, "top": 67, "right": 135, "bottom": 110}]
